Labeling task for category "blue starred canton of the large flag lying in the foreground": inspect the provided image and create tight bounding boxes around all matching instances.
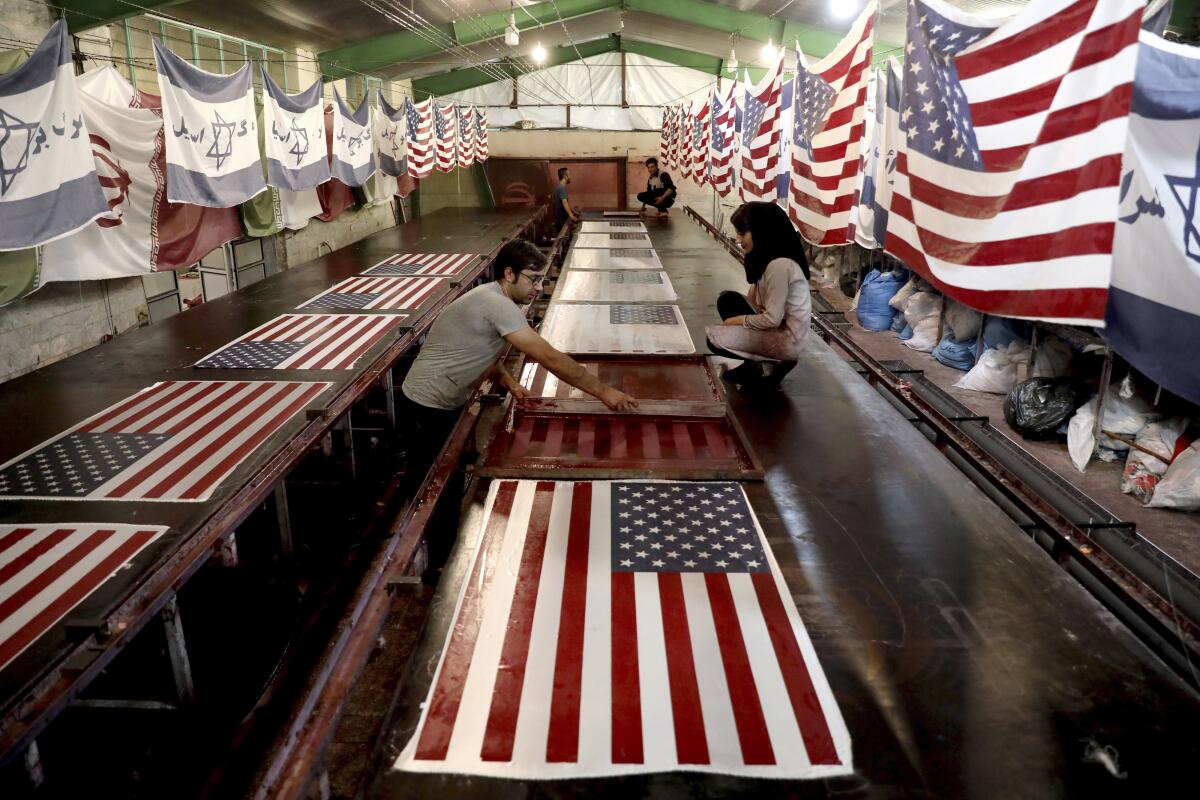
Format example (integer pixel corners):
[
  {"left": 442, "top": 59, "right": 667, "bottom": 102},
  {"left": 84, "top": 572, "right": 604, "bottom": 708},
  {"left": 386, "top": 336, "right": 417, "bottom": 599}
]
[{"left": 612, "top": 483, "right": 770, "bottom": 573}]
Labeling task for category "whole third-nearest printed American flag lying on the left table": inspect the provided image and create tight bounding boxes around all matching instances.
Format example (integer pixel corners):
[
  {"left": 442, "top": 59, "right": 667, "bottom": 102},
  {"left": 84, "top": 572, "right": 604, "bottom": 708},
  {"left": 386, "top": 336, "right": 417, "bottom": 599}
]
[{"left": 196, "top": 314, "right": 403, "bottom": 369}]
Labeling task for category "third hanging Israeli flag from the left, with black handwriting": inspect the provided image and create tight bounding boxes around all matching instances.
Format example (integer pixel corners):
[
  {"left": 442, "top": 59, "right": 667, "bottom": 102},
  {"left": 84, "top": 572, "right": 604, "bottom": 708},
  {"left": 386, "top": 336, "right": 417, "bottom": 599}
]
[{"left": 259, "top": 66, "right": 329, "bottom": 192}]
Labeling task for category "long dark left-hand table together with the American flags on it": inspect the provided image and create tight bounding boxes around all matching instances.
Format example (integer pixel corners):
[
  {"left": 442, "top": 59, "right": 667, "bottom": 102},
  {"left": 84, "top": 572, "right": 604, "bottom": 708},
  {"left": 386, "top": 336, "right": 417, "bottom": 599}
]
[{"left": 0, "top": 209, "right": 541, "bottom": 762}]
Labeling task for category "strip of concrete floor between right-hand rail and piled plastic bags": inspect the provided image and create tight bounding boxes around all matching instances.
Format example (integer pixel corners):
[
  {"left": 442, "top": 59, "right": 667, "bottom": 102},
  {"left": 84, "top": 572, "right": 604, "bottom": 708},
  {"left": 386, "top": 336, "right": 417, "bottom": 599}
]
[{"left": 821, "top": 288, "right": 1200, "bottom": 573}]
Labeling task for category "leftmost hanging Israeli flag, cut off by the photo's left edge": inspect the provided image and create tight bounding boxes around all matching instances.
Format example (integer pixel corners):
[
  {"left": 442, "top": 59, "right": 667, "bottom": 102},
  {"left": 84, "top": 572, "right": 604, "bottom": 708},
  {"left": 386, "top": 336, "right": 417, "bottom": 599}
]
[{"left": 0, "top": 20, "right": 108, "bottom": 251}]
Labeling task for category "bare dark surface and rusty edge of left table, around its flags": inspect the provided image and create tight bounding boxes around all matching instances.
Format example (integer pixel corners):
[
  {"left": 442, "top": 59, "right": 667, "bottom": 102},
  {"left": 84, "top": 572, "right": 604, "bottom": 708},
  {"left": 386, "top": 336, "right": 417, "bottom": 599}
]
[{"left": 0, "top": 209, "right": 539, "bottom": 760}]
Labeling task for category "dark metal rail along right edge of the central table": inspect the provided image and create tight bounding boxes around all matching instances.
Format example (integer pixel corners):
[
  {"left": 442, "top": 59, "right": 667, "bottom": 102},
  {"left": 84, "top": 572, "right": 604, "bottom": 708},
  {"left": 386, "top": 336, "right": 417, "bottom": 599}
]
[{"left": 684, "top": 206, "right": 1200, "bottom": 688}]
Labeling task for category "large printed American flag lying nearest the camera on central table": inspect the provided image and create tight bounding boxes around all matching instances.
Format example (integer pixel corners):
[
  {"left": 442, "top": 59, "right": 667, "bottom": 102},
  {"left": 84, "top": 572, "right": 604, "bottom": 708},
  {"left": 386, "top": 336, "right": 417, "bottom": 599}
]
[{"left": 396, "top": 481, "right": 852, "bottom": 780}]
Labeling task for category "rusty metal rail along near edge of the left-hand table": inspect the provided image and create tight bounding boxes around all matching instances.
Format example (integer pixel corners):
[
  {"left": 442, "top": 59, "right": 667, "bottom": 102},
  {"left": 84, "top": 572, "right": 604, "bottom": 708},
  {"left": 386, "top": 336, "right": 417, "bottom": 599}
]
[{"left": 0, "top": 206, "right": 545, "bottom": 766}]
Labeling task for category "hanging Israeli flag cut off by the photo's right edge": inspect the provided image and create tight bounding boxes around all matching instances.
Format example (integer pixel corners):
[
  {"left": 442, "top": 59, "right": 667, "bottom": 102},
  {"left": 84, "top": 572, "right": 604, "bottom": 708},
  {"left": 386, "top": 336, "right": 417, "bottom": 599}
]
[{"left": 1104, "top": 30, "right": 1200, "bottom": 402}]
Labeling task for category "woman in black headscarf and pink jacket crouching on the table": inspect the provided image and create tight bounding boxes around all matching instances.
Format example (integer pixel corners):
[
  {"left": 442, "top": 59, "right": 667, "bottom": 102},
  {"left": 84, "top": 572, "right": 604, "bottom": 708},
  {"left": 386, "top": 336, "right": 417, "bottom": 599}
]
[{"left": 704, "top": 203, "right": 812, "bottom": 389}]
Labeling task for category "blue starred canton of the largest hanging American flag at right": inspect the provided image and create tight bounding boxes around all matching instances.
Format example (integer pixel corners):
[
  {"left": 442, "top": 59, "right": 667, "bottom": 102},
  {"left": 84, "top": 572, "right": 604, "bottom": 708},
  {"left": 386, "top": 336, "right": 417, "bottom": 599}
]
[{"left": 900, "top": 0, "right": 992, "bottom": 170}]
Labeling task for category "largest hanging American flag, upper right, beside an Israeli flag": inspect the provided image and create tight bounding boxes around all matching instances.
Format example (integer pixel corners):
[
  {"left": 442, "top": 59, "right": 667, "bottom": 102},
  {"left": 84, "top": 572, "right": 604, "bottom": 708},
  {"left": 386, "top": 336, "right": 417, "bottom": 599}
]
[{"left": 886, "top": 0, "right": 1142, "bottom": 325}]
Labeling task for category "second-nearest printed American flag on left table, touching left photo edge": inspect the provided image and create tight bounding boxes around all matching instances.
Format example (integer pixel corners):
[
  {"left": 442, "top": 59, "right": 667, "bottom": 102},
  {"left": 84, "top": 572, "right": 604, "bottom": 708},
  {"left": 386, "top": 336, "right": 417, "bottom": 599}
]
[{"left": 0, "top": 380, "right": 331, "bottom": 501}]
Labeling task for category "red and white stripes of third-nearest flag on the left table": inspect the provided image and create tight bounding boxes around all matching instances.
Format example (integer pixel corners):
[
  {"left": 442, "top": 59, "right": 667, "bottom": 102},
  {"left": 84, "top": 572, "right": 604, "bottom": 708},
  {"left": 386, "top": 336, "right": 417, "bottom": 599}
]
[{"left": 200, "top": 314, "right": 404, "bottom": 369}]
